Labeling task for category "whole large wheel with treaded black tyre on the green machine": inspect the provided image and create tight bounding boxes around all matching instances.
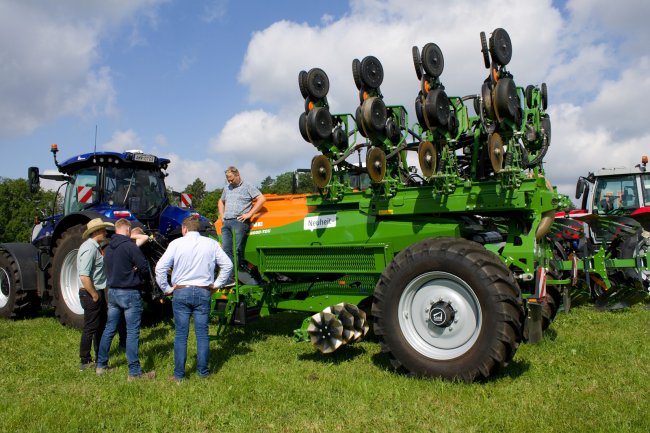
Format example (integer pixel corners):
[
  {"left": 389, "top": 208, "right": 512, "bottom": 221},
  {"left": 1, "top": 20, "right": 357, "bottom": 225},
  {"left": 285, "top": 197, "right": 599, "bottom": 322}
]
[{"left": 372, "top": 238, "right": 525, "bottom": 382}]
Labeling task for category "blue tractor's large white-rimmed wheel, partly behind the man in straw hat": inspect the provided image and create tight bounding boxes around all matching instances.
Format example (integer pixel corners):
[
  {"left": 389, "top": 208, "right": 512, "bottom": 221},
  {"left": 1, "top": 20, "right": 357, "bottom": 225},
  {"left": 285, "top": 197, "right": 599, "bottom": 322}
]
[{"left": 50, "top": 224, "right": 86, "bottom": 329}]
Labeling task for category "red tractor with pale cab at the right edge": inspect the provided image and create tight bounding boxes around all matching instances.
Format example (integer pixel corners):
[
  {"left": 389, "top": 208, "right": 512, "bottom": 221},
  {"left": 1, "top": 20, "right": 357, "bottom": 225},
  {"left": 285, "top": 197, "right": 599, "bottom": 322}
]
[{"left": 549, "top": 156, "right": 650, "bottom": 309}]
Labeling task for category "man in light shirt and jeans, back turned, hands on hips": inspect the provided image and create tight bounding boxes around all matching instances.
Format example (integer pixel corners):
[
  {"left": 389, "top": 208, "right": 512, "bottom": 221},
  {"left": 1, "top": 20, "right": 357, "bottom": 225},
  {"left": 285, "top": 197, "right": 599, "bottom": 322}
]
[{"left": 156, "top": 216, "right": 233, "bottom": 383}]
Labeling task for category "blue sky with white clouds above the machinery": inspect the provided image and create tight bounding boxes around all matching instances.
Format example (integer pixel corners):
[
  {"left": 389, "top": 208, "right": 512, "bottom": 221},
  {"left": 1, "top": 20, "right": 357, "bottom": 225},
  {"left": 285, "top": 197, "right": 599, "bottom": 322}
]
[{"left": 0, "top": 0, "right": 650, "bottom": 199}]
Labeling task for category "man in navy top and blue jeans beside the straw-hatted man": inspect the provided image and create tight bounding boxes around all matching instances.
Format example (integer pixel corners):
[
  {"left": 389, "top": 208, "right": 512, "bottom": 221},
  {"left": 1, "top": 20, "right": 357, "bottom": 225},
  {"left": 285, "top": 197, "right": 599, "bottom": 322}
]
[{"left": 96, "top": 219, "right": 156, "bottom": 382}]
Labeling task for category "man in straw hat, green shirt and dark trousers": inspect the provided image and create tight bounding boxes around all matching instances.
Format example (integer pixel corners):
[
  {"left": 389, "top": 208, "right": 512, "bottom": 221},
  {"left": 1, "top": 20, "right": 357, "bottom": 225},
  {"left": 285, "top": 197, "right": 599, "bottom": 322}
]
[{"left": 77, "top": 218, "right": 113, "bottom": 371}]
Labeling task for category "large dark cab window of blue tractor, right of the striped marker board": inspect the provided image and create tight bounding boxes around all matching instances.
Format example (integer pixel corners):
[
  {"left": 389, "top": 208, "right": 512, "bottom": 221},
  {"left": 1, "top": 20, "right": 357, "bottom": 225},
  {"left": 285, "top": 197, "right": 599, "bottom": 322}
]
[{"left": 105, "top": 167, "right": 165, "bottom": 219}]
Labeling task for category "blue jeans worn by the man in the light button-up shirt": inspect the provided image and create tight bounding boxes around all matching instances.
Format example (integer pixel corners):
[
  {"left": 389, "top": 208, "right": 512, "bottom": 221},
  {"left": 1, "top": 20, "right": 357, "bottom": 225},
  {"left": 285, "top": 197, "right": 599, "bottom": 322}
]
[{"left": 172, "top": 287, "right": 210, "bottom": 379}]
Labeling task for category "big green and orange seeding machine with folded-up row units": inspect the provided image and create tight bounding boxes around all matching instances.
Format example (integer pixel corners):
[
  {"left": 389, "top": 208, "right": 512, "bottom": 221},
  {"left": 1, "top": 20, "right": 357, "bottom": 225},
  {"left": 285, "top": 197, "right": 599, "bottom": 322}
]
[{"left": 210, "top": 29, "right": 568, "bottom": 382}]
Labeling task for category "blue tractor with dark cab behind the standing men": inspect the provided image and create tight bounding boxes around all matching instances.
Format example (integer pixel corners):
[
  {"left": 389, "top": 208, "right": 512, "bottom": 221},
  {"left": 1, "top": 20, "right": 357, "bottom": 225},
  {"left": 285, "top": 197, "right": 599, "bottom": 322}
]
[{"left": 0, "top": 144, "right": 216, "bottom": 328}]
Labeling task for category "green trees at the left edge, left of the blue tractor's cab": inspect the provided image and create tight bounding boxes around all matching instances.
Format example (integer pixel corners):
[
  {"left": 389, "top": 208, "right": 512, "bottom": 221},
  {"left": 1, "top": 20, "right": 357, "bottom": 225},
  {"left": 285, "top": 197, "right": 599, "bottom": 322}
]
[{"left": 0, "top": 177, "right": 61, "bottom": 242}]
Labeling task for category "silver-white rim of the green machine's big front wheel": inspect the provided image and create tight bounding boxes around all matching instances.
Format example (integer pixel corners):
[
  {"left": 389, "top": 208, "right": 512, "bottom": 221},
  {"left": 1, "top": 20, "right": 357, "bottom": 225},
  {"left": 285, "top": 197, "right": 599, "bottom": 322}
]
[{"left": 398, "top": 271, "right": 482, "bottom": 360}]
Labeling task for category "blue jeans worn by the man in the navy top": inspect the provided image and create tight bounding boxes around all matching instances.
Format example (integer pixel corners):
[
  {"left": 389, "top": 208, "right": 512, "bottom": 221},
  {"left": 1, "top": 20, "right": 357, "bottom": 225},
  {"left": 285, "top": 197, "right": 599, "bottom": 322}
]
[{"left": 97, "top": 289, "right": 143, "bottom": 376}]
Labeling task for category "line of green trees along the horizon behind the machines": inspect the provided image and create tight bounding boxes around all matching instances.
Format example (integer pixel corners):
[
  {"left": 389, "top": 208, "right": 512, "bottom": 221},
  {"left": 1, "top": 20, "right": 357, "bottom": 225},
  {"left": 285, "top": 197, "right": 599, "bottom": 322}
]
[{"left": 0, "top": 172, "right": 317, "bottom": 242}]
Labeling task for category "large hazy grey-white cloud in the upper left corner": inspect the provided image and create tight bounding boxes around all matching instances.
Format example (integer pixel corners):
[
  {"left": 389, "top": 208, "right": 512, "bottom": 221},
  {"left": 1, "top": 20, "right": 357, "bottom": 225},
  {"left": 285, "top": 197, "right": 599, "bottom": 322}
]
[{"left": 0, "top": 0, "right": 166, "bottom": 138}]
